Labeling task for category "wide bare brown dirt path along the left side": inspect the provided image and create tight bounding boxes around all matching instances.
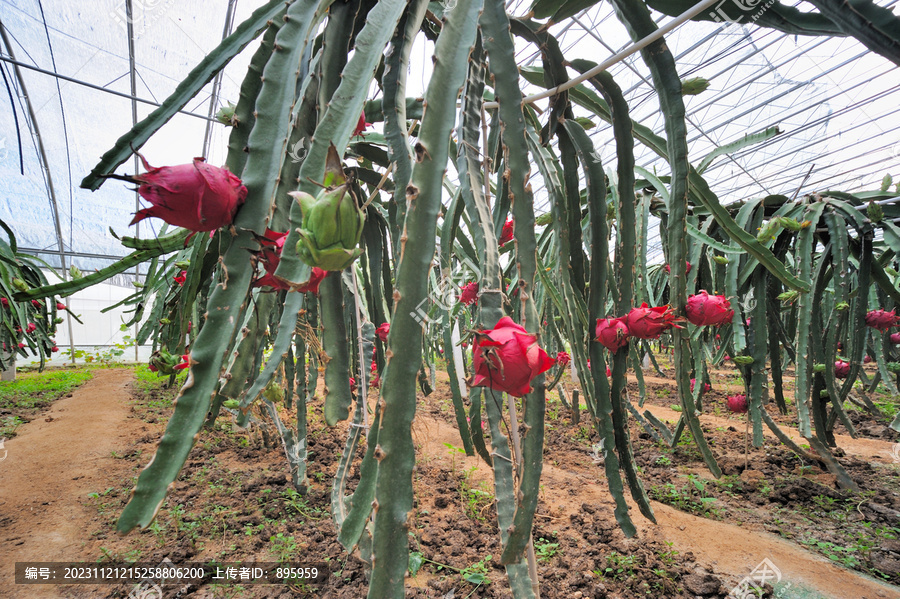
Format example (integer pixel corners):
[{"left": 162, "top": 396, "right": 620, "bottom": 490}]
[{"left": 0, "top": 368, "right": 142, "bottom": 599}]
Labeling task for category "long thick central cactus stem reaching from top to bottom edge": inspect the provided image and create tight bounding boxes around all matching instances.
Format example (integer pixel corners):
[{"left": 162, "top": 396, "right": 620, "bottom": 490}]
[{"left": 366, "top": 0, "right": 481, "bottom": 599}]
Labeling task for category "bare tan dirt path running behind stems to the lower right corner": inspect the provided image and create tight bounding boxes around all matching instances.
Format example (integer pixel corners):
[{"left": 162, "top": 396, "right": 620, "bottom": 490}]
[{"left": 413, "top": 406, "right": 897, "bottom": 599}]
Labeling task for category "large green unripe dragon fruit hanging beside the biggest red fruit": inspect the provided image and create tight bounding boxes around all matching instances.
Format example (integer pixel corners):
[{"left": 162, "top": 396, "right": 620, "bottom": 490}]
[{"left": 289, "top": 145, "right": 366, "bottom": 271}]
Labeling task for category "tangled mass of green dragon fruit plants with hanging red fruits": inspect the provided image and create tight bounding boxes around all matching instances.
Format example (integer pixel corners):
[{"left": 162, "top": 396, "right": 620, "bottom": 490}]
[{"left": 12, "top": 0, "right": 900, "bottom": 599}]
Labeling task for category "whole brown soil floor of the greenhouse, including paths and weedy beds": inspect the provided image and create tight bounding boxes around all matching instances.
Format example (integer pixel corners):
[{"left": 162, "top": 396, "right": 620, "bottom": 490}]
[{"left": 0, "top": 369, "right": 900, "bottom": 599}]
